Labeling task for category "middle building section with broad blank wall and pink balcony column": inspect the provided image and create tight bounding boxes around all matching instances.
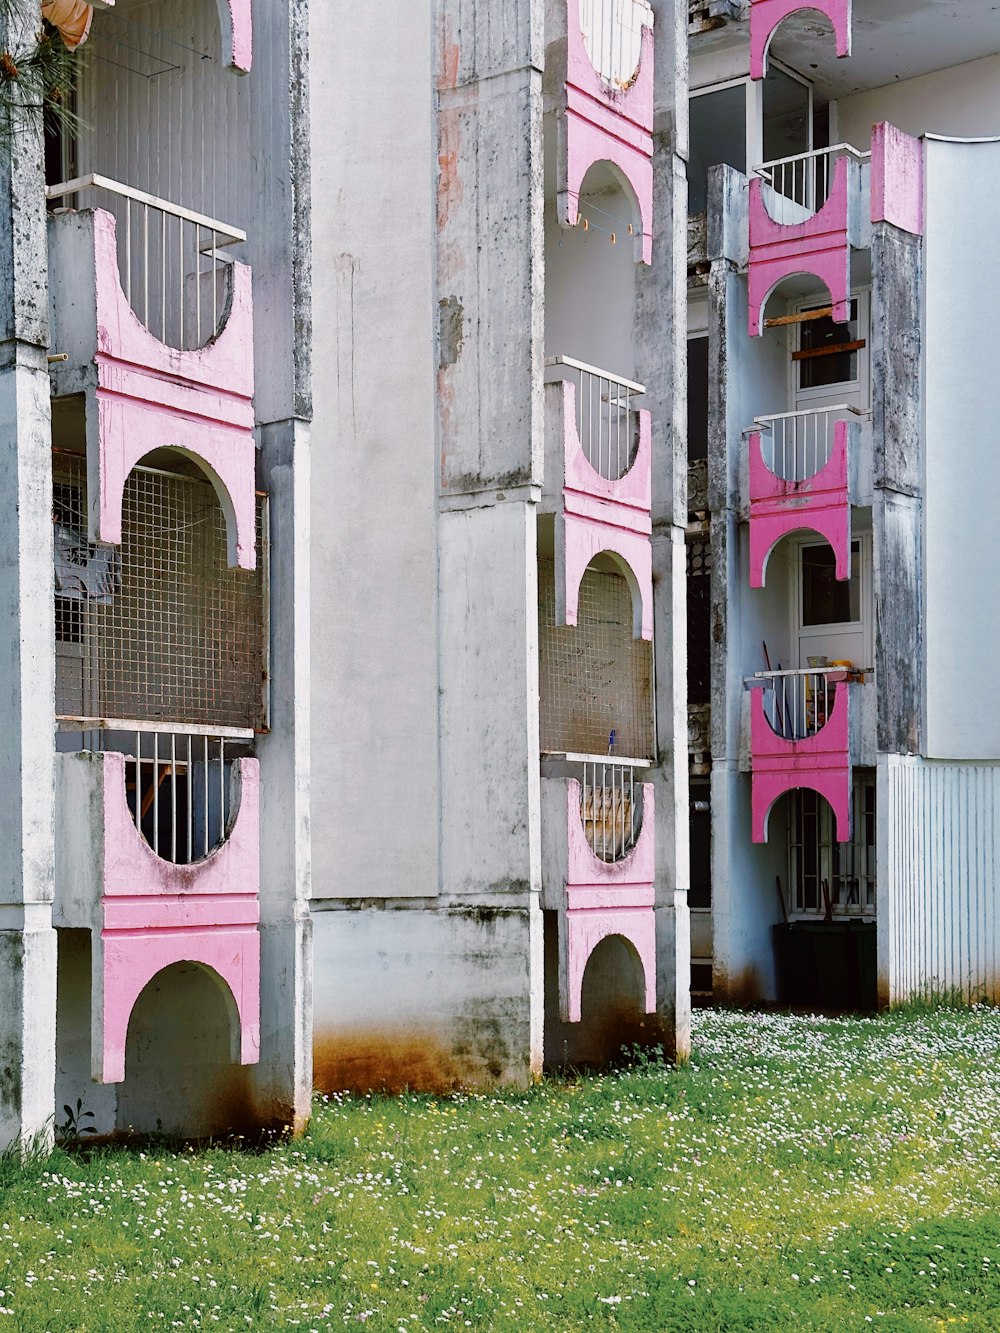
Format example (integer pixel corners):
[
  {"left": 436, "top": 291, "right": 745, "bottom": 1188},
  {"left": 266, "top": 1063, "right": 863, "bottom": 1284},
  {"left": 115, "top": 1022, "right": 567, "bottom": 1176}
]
[{"left": 311, "top": 0, "right": 689, "bottom": 1089}]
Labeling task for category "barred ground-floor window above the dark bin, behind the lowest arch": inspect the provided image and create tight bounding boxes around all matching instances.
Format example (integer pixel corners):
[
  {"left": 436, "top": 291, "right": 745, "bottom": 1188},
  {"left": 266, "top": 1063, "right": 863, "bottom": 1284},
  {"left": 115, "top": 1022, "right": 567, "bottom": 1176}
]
[{"left": 788, "top": 774, "right": 876, "bottom": 916}]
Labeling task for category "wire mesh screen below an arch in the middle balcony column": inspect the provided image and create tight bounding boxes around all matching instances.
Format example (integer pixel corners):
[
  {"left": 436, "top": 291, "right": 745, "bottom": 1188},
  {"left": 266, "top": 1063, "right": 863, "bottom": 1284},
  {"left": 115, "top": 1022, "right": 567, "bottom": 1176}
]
[{"left": 539, "top": 560, "right": 653, "bottom": 758}]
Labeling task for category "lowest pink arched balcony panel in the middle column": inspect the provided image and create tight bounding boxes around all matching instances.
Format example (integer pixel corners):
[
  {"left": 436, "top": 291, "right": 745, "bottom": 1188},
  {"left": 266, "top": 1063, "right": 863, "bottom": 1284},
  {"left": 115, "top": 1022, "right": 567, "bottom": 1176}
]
[{"left": 560, "top": 778, "right": 656, "bottom": 1022}]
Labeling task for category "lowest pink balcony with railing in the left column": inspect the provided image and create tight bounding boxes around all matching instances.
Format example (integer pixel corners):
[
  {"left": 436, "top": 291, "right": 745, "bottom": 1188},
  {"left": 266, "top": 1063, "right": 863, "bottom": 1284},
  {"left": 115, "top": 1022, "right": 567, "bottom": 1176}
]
[{"left": 53, "top": 726, "right": 260, "bottom": 1082}]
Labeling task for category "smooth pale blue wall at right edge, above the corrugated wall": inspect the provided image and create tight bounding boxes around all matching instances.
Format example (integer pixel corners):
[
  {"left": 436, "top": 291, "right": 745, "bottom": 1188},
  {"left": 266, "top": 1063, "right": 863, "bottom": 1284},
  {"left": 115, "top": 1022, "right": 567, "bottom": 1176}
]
[{"left": 924, "top": 140, "right": 1000, "bottom": 760}]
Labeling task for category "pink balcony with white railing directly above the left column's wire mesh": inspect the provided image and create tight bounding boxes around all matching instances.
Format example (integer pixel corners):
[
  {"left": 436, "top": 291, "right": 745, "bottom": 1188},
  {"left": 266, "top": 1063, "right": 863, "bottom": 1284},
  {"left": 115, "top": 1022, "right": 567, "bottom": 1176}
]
[{"left": 48, "top": 176, "right": 256, "bottom": 569}]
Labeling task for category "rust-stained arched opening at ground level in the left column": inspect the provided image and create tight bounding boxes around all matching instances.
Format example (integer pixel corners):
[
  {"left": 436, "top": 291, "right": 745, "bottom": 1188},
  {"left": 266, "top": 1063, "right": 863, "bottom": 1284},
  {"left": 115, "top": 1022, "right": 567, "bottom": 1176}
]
[{"left": 117, "top": 962, "right": 252, "bottom": 1138}]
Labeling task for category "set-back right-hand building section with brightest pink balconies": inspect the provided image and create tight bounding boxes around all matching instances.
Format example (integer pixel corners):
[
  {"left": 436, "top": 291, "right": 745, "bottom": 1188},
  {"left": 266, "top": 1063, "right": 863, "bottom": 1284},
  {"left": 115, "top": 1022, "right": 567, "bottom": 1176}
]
[{"left": 688, "top": 0, "right": 1000, "bottom": 1008}]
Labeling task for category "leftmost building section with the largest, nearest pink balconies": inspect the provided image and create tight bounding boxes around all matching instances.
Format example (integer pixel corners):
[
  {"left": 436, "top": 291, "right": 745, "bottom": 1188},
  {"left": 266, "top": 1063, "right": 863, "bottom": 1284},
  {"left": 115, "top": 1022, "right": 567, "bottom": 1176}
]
[{"left": 0, "top": 0, "right": 311, "bottom": 1146}]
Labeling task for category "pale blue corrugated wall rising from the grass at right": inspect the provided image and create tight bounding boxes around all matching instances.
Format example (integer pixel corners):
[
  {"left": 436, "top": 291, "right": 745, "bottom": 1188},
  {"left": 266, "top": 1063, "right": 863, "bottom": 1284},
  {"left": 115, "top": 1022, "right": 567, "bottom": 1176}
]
[{"left": 877, "top": 756, "right": 1000, "bottom": 1004}]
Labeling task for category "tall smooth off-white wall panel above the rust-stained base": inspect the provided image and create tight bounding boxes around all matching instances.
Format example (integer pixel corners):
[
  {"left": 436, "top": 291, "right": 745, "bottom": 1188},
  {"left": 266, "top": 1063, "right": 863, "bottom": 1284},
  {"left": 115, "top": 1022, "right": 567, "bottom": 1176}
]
[{"left": 311, "top": 4, "right": 439, "bottom": 898}]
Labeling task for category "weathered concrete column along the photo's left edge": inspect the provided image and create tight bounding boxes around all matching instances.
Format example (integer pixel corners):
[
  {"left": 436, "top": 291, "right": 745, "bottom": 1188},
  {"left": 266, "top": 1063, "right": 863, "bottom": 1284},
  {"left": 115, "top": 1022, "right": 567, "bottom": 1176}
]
[{"left": 0, "top": 0, "right": 56, "bottom": 1150}]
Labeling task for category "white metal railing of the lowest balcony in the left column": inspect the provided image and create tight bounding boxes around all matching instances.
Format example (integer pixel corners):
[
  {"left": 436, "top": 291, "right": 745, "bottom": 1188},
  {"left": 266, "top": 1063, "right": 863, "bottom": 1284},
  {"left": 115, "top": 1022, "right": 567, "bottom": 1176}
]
[{"left": 61, "top": 721, "right": 252, "bottom": 865}]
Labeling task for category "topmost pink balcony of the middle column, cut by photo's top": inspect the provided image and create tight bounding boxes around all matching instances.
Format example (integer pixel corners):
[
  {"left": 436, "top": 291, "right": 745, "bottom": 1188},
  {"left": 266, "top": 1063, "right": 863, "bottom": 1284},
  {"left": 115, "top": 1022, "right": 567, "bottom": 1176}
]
[{"left": 555, "top": 0, "right": 653, "bottom": 264}]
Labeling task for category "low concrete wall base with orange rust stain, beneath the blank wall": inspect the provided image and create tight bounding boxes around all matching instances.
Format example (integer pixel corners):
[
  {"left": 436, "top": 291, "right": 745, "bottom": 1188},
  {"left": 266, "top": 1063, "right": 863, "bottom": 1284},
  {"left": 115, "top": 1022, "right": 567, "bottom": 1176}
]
[{"left": 315, "top": 893, "right": 541, "bottom": 1092}]
